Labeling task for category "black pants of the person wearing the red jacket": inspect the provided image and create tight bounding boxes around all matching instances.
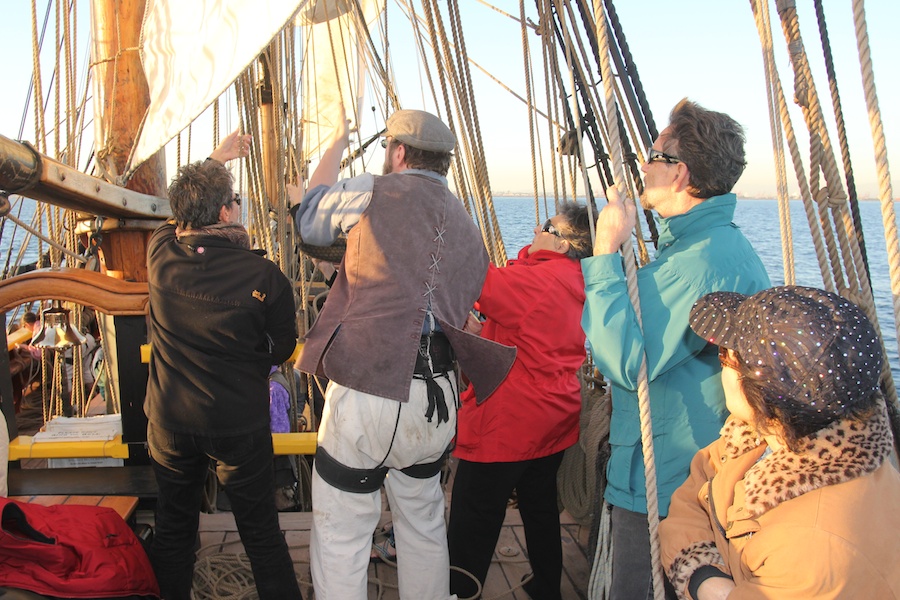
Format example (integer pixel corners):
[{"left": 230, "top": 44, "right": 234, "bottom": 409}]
[{"left": 447, "top": 452, "right": 563, "bottom": 600}]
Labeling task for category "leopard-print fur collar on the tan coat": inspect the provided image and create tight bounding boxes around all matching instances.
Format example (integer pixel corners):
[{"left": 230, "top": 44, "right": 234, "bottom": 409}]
[{"left": 722, "top": 403, "right": 893, "bottom": 517}]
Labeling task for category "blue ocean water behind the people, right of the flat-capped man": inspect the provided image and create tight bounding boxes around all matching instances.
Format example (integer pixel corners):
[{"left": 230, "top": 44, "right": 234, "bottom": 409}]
[{"left": 494, "top": 197, "right": 900, "bottom": 385}]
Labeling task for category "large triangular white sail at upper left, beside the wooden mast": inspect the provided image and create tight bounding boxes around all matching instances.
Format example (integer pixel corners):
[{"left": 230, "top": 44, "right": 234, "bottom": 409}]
[{"left": 129, "top": 0, "right": 308, "bottom": 170}]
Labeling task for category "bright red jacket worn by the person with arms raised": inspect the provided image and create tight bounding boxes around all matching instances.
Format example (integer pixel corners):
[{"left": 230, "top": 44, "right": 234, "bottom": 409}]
[{"left": 454, "top": 246, "right": 586, "bottom": 462}]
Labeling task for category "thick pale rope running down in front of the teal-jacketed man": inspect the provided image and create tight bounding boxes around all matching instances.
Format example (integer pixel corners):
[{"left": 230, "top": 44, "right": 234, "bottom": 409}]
[{"left": 592, "top": 0, "right": 665, "bottom": 600}]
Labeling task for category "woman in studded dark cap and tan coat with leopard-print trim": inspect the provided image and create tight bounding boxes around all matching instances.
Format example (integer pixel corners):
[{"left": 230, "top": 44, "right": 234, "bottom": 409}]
[{"left": 660, "top": 286, "right": 900, "bottom": 600}]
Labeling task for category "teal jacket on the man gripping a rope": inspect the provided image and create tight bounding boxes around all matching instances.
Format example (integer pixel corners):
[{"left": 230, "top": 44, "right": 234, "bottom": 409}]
[{"left": 581, "top": 194, "right": 771, "bottom": 516}]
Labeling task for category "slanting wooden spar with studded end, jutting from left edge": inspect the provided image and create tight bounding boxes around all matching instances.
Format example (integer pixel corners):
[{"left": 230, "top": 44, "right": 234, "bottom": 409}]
[{"left": 0, "top": 135, "right": 172, "bottom": 219}]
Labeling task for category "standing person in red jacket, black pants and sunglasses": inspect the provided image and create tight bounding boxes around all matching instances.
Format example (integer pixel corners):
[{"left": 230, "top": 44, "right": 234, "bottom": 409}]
[{"left": 448, "top": 203, "right": 596, "bottom": 600}]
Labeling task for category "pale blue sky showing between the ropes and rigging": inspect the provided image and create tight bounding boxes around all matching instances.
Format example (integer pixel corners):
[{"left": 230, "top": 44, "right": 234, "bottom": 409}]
[{"left": 0, "top": 0, "right": 900, "bottom": 198}]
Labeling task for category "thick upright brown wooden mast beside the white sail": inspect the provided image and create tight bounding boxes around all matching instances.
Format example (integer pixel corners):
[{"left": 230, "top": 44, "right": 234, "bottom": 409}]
[{"left": 91, "top": 0, "right": 168, "bottom": 281}]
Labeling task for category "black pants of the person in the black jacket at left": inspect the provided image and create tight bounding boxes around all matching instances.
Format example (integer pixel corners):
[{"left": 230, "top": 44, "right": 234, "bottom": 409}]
[{"left": 147, "top": 424, "right": 302, "bottom": 600}]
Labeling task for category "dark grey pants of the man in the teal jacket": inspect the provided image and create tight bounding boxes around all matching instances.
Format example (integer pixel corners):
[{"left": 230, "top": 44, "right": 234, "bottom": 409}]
[{"left": 609, "top": 506, "right": 675, "bottom": 600}]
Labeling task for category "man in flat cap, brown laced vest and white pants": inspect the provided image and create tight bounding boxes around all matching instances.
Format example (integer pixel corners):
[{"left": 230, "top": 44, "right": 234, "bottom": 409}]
[{"left": 289, "top": 110, "right": 515, "bottom": 600}]
